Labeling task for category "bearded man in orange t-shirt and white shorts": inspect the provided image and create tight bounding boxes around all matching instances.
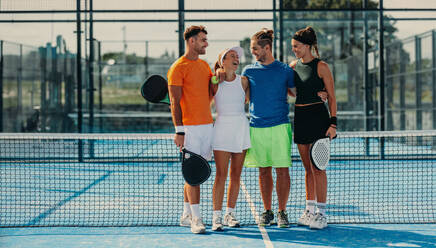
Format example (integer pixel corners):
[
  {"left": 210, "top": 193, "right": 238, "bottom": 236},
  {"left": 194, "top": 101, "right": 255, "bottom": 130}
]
[{"left": 167, "top": 26, "right": 213, "bottom": 233}]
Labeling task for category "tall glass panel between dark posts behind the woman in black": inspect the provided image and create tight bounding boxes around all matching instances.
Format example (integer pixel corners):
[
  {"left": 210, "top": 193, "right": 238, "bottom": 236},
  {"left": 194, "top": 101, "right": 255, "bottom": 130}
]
[{"left": 284, "top": 11, "right": 378, "bottom": 130}]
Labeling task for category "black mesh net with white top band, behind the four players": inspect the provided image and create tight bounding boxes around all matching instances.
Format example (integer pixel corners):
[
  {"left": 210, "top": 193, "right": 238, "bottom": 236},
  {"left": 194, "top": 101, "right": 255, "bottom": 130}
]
[{"left": 0, "top": 131, "right": 436, "bottom": 227}]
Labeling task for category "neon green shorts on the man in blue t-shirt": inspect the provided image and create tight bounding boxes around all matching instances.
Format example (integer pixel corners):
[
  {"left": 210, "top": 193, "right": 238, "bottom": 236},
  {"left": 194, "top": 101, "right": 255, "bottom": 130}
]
[{"left": 244, "top": 123, "right": 292, "bottom": 168}]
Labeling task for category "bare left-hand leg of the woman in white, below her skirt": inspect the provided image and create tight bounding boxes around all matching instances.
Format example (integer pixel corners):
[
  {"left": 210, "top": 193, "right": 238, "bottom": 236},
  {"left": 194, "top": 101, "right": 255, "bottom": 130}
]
[{"left": 212, "top": 151, "right": 230, "bottom": 211}]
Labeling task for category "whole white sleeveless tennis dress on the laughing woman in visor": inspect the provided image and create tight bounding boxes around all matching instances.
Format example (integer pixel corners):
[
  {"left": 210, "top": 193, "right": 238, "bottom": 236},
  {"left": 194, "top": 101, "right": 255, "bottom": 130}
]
[{"left": 212, "top": 75, "right": 251, "bottom": 153}]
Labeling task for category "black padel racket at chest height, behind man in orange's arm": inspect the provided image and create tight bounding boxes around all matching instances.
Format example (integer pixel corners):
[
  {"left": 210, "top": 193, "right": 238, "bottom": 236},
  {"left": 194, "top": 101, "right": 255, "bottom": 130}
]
[{"left": 141, "top": 75, "right": 170, "bottom": 104}]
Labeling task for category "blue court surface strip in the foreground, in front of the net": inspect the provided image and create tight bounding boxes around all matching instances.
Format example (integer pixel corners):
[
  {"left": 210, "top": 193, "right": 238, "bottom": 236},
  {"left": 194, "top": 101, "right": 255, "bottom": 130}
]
[{"left": 0, "top": 224, "right": 436, "bottom": 248}]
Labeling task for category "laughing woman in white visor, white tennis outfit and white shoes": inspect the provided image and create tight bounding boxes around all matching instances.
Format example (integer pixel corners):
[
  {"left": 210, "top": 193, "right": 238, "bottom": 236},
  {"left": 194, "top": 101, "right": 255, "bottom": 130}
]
[{"left": 211, "top": 47, "right": 251, "bottom": 231}]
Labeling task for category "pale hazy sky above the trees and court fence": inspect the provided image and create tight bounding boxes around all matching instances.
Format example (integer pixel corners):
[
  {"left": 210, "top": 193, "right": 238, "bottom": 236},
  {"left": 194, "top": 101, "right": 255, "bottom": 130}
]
[{"left": 0, "top": 0, "right": 436, "bottom": 62}]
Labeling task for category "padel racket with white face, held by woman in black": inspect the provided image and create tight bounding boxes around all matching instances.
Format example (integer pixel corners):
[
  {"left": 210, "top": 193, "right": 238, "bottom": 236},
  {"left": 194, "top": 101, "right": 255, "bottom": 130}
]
[{"left": 310, "top": 135, "right": 337, "bottom": 170}]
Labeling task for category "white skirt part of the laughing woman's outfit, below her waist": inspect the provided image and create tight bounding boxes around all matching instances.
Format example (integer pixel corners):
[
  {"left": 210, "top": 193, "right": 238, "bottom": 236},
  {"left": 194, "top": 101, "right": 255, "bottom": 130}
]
[{"left": 212, "top": 114, "right": 251, "bottom": 153}]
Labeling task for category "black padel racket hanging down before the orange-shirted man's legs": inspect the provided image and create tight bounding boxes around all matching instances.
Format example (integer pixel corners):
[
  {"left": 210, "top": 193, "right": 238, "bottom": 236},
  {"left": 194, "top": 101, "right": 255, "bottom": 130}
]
[{"left": 182, "top": 148, "right": 211, "bottom": 186}]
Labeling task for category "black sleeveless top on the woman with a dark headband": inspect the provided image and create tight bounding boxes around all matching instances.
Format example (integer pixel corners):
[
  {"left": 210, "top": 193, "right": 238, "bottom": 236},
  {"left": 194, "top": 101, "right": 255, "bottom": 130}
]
[{"left": 294, "top": 58, "right": 324, "bottom": 104}]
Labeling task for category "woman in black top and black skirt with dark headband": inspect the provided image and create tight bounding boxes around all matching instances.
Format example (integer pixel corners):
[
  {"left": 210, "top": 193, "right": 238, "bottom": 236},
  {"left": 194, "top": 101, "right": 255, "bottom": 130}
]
[{"left": 291, "top": 27, "right": 337, "bottom": 229}]
